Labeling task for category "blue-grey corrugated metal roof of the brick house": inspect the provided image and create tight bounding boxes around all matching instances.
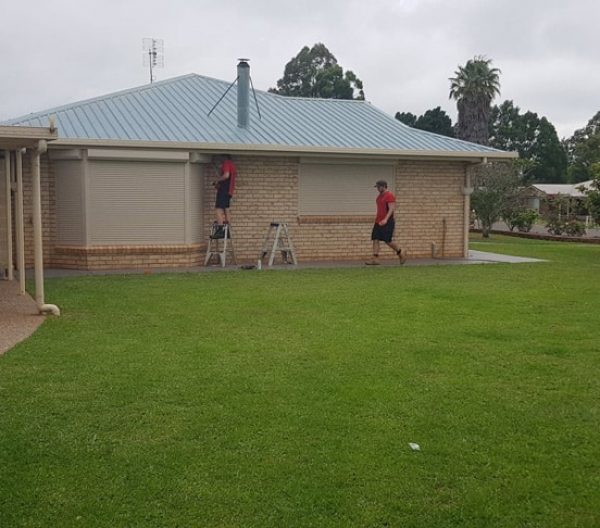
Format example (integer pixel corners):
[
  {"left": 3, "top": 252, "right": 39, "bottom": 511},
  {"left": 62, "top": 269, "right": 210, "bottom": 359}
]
[{"left": 3, "top": 74, "right": 505, "bottom": 157}]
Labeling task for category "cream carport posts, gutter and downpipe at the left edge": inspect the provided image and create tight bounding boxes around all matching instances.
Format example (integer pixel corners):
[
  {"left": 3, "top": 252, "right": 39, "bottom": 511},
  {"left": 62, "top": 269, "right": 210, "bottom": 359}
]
[{"left": 0, "top": 124, "right": 60, "bottom": 315}]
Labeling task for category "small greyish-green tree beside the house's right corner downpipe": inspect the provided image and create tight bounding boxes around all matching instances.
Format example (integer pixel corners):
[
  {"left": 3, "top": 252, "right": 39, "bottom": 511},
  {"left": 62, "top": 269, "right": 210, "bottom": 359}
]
[{"left": 471, "top": 163, "right": 521, "bottom": 238}]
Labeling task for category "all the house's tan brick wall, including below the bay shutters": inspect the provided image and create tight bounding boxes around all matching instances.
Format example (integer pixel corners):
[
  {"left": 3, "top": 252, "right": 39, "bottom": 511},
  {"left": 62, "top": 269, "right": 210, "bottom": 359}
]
[{"left": 16, "top": 152, "right": 466, "bottom": 269}]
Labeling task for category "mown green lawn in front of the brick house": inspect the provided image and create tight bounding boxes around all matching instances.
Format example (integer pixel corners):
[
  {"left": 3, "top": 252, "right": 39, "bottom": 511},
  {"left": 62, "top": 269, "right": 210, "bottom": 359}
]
[{"left": 0, "top": 236, "right": 600, "bottom": 528}]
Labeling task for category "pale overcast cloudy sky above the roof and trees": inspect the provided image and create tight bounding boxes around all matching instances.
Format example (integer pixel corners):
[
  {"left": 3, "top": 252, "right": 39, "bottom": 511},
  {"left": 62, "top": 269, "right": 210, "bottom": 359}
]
[{"left": 0, "top": 0, "right": 600, "bottom": 137}]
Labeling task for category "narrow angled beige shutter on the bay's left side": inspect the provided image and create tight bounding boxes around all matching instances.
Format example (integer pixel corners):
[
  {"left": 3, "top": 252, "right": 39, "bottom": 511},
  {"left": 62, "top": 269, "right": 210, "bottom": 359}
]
[{"left": 55, "top": 161, "right": 85, "bottom": 245}]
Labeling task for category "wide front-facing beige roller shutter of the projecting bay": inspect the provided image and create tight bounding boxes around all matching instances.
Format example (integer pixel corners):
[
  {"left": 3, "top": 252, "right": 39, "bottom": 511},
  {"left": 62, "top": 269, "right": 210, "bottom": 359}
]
[{"left": 88, "top": 160, "right": 185, "bottom": 245}]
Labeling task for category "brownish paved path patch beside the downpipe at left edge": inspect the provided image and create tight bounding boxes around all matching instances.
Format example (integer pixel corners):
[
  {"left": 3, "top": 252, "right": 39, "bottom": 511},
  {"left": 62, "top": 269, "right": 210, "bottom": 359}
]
[{"left": 0, "top": 280, "right": 44, "bottom": 354}]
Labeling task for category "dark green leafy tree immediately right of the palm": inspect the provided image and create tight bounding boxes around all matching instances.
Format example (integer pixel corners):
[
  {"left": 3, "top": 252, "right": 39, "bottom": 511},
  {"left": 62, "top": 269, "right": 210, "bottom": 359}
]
[{"left": 489, "top": 101, "right": 567, "bottom": 183}]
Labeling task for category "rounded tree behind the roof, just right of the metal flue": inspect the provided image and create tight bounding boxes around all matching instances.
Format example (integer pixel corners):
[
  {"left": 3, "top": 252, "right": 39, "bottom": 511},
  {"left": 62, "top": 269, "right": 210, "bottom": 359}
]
[{"left": 269, "top": 43, "right": 365, "bottom": 100}]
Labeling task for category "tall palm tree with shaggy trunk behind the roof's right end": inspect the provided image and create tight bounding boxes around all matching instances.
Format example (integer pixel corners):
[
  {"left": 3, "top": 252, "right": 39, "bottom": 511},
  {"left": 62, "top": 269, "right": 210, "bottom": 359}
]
[{"left": 449, "top": 56, "right": 501, "bottom": 145}]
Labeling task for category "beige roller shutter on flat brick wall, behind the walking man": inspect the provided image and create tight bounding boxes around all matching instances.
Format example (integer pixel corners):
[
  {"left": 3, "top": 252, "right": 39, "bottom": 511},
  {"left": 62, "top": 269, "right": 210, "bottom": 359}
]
[{"left": 298, "top": 163, "right": 394, "bottom": 216}]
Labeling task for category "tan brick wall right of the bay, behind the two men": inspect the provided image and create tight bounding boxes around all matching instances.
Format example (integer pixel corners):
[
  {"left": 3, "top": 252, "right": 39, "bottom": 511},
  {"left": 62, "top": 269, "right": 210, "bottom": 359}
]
[{"left": 204, "top": 156, "right": 465, "bottom": 262}]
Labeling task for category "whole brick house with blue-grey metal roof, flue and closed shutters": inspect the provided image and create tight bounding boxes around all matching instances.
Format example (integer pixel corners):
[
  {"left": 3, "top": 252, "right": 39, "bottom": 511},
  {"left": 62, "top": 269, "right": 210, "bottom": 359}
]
[{"left": 0, "top": 62, "right": 516, "bottom": 269}]
